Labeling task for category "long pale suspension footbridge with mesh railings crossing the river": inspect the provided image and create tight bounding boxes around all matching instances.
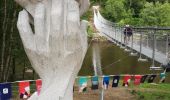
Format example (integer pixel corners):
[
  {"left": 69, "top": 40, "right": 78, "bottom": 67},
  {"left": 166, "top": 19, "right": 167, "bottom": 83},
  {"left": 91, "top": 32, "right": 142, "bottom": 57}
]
[{"left": 93, "top": 7, "right": 170, "bottom": 70}]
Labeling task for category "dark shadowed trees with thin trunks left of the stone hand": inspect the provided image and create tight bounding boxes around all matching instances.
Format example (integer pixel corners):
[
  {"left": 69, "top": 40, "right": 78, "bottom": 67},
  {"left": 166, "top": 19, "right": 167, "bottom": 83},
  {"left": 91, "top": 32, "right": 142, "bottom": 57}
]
[{"left": 0, "top": 0, "right": 29, "bottom": 82}]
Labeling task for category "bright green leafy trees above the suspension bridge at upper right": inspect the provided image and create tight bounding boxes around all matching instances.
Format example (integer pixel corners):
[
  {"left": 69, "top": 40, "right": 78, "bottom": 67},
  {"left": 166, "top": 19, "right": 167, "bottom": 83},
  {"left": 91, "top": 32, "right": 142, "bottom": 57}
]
[{"left": 101, "top": 0, "right": 170, "bottom": 26}]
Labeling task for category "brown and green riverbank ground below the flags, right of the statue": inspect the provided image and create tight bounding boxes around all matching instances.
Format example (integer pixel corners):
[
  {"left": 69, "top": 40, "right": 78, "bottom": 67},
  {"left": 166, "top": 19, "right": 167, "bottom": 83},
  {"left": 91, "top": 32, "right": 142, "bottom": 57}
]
[{"left": 74, "top": 83, "right": 170, "bottom": 100}]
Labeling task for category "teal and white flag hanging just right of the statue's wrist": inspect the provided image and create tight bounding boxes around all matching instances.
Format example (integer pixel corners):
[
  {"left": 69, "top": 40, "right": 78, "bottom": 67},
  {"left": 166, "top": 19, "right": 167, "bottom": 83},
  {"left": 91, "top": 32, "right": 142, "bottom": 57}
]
[{"left": 79, "top": 77, "right": 87, "bottom": 92}]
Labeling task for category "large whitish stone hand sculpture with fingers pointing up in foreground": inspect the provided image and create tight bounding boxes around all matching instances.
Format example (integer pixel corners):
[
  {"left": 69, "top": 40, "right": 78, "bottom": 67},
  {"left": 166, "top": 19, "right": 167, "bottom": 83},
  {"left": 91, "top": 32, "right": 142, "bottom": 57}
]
[{"left": 16, "top": 0, "right": 89, "bottom": 100}]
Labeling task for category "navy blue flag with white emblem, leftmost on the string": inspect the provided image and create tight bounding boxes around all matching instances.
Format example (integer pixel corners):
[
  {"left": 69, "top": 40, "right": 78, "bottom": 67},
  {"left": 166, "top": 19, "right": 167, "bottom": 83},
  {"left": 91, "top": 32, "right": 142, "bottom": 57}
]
[{"left": 0, "top": 83, "right": 12, "bottom": 100}]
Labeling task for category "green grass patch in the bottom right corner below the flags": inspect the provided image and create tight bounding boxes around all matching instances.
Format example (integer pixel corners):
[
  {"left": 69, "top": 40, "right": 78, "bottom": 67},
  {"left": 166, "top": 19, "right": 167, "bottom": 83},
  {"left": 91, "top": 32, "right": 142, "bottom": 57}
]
[{"left": 130, "top": 83, "right": 170, "bottom": 100}]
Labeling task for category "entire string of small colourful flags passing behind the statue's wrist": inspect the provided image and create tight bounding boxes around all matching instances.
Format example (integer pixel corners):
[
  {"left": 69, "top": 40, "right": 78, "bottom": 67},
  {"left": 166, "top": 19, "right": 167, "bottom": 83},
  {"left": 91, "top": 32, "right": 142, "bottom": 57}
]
[{"left": 0, "top": 73, "right": 166, "bottom": 100}]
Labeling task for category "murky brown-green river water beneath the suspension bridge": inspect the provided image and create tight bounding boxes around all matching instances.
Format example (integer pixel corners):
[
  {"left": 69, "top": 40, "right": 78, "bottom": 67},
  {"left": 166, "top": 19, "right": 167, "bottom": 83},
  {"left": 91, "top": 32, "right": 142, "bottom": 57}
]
[{"left": 79, "top": 42, "right": 170, "bottom": 83}]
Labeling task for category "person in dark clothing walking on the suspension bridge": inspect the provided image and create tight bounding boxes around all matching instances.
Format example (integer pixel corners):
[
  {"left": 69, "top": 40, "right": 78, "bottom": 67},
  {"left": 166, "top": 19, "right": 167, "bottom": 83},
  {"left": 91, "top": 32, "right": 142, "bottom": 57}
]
[{"left": 124, "top": 25, "right": 133, "bottom": 43}]
